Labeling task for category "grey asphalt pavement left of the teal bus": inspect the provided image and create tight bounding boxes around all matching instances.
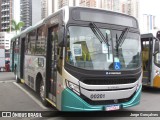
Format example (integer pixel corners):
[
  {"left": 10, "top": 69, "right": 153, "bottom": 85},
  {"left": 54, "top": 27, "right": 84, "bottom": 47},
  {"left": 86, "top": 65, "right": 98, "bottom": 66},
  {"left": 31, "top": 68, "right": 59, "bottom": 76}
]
[{"left": 0, "top": 72, "right": 47, "bottom": 111}]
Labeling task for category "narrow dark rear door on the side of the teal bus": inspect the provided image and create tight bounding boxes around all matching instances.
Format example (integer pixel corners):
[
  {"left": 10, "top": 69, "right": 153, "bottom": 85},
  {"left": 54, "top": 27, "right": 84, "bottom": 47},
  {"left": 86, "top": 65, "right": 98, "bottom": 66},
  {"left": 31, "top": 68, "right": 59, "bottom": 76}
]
[{"left": 20, "top": 38, "right": 25, "bottom": 78}]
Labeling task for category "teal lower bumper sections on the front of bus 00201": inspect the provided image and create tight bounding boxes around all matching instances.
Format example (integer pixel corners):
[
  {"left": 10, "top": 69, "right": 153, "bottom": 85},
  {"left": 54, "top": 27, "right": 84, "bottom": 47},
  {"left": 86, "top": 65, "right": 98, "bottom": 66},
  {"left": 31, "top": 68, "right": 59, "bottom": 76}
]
[{"left": 61, "top": 85, "right": 142, "bottom": 111}]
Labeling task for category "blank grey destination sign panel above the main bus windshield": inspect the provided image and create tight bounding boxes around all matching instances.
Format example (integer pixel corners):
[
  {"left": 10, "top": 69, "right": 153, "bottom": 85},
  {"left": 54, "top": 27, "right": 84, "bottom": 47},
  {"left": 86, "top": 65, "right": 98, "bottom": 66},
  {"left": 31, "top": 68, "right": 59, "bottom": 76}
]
[{"left": 72, "top": 9, "right": 138, "bottom": 28}]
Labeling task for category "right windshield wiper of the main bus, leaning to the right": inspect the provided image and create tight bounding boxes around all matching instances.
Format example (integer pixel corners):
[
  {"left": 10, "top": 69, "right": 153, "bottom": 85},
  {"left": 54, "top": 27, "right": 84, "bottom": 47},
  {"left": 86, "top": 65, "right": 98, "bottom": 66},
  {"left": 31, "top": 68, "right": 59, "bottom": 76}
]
[{"left": 116, "top": 27, "right": 130, "bottom": 48}]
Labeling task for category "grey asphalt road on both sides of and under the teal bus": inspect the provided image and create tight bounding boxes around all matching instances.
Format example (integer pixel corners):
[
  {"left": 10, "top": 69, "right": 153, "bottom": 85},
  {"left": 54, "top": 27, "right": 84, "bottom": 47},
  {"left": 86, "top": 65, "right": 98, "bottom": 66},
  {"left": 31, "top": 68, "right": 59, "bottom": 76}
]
[{"left": 0, "top": 72, "right": 160, "bottom": 120}]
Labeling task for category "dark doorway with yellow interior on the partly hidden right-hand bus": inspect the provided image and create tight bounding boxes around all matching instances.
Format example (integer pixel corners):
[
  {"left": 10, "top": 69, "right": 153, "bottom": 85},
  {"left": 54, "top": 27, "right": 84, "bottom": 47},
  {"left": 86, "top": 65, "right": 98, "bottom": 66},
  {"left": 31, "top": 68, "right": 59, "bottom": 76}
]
[{"left": 141, "top": 37, "right": 153, "bottom": 85}]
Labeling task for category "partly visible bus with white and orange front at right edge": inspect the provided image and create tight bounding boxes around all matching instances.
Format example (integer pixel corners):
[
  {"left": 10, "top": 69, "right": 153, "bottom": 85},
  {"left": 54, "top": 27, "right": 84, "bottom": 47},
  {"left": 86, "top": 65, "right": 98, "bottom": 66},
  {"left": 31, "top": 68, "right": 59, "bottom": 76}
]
[{"left": 141, "top": 31, "right": 160, "bottom": 88}]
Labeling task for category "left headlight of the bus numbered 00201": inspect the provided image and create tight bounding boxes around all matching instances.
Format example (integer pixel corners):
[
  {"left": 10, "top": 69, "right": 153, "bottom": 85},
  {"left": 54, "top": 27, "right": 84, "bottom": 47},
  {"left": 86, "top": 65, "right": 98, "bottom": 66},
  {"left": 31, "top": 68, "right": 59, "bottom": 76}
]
[{"left": 66, "top": 80, "right": 80, "bottom": 95}]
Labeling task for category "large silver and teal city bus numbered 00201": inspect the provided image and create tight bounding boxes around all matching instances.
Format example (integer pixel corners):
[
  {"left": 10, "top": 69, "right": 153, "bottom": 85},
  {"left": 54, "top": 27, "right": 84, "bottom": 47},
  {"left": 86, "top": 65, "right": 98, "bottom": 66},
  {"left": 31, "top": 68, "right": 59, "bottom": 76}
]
[{"left": 12, "top": 6, "right": 142, "bottom": 111}]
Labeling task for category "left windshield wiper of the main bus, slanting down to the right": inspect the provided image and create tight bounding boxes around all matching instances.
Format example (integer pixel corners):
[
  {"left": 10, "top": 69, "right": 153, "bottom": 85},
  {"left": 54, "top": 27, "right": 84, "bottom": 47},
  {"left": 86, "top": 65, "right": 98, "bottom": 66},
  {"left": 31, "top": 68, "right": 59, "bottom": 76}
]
[{"left": 89, "top": 22, "right": 110, "bottom": 46}]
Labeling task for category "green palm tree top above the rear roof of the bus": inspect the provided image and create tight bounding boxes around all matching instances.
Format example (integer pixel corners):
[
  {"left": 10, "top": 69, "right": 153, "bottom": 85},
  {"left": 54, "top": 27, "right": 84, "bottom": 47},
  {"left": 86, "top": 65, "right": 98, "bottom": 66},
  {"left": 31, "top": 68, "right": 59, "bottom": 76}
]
[{"left": 7, "top": 20, "right": 25, "bottom": 34}]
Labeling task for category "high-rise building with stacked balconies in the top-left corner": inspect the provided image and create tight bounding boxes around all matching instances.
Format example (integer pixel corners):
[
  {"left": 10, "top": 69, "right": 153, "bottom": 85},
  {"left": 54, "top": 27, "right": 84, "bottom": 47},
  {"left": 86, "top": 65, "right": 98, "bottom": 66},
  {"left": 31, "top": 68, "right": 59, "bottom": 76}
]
[{"left": 0, "top": 0, "right": 13, "bottom": 32}]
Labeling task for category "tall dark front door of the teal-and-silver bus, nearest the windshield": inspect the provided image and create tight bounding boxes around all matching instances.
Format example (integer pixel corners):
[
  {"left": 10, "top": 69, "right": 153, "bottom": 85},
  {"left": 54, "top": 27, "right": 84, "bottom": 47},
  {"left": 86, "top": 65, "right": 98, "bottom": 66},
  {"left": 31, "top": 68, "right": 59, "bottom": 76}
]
[{"left": 47, "top": 25, "right": 58, "bottom": 103}]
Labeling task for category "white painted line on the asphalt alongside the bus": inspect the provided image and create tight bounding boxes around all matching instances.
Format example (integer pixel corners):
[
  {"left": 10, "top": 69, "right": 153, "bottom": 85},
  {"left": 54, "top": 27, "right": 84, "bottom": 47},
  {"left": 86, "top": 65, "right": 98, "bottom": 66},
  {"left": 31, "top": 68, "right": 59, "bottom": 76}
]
[{"left": 13, "top": 82, "right": 48, "bottom": 109}]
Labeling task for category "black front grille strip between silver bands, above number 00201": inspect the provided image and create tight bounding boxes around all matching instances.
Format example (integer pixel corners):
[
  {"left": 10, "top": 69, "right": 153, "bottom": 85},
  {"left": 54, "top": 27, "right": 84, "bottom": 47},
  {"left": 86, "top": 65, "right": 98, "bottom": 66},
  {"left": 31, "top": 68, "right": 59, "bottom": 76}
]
[{"left": 82, "top": 78, "right": 137, "bottom": 85}]
